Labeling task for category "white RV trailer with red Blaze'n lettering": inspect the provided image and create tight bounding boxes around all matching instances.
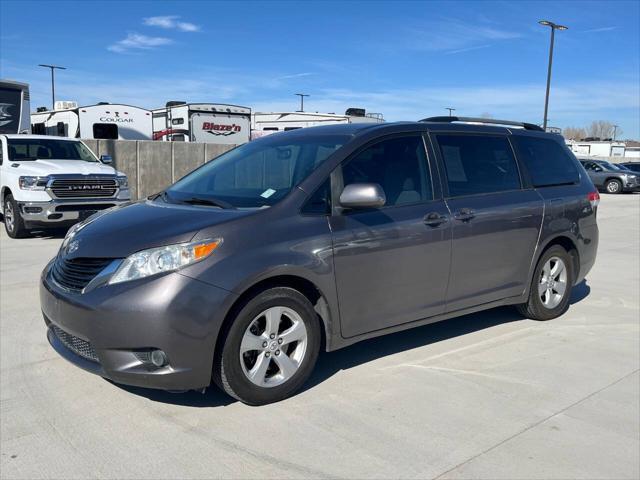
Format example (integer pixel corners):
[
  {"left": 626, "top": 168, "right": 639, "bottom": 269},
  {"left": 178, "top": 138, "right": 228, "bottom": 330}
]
[{"left": 153, "top": 102, "right": 251, "bottom": 145}]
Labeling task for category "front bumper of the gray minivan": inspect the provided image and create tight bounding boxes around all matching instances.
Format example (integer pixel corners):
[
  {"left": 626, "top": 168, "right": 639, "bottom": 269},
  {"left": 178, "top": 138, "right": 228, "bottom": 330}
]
[{"left": 40, "top": 263, "right": 236, "bottom": 390}]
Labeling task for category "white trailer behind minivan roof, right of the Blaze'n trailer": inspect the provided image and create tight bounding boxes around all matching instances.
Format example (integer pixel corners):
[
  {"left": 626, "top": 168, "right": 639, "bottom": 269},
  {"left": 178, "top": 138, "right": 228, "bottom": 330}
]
[{"left": 251, "top": 108, "right": 384, "bottom": 138}]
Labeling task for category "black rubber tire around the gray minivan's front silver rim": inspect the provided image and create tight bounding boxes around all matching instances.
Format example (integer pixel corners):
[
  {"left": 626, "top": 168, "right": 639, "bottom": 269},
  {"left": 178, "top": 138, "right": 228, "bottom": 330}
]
[{"left": 213, "top": 287, "right": 321, "bottom": 405}]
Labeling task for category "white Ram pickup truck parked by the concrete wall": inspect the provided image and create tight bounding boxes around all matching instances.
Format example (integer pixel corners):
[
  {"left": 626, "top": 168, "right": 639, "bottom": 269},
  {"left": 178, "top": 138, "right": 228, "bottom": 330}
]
[{"left": 0, "top": 135, "right": 131, "bottom": 238}]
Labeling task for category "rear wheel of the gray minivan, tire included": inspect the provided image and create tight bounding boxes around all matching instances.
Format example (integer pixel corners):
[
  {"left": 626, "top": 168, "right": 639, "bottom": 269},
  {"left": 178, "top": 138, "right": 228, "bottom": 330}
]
[{"left": 517, "top": 245, "right": 574, "bottom": 320}]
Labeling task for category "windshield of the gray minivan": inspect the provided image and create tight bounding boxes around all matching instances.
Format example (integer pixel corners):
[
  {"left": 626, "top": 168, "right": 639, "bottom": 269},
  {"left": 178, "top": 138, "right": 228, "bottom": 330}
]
[{"left": 163, "top": 134, "right": 348, "bottom": 208}]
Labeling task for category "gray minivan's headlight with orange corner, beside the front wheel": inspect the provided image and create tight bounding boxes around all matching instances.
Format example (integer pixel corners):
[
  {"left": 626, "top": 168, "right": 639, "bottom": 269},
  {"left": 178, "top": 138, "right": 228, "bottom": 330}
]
[{"left": 109, "top": 238, "right": 222, "bottom": 284}]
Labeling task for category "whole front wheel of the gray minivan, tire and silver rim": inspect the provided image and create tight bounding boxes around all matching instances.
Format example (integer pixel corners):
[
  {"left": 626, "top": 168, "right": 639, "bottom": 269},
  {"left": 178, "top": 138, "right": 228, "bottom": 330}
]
[{"left": 213, "top": 287, "right": 321, "bottom": 405}]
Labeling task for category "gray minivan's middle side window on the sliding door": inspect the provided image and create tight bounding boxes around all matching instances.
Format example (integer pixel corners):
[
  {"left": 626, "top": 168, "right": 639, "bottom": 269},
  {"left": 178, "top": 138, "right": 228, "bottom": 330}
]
[{"left": 437, "top": 135, "right": 521, "bottom": 197}]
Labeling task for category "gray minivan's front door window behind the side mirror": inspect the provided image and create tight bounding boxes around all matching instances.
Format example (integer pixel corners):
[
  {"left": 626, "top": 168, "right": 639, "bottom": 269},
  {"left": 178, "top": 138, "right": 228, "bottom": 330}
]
[{"left": 342, "top": 135, "right": 433, "bottom": 206}]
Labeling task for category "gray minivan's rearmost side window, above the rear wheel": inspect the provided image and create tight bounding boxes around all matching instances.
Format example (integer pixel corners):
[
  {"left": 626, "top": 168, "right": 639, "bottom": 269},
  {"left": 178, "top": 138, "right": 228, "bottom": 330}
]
[{"left": 511, "top": 136, "right": 580, "bottom": 187}]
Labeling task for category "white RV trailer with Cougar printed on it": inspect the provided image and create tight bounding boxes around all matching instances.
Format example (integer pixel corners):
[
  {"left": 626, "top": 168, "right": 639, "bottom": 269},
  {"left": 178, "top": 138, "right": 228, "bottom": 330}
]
[{"left": 31, "top": 102, "right": 153, "bottom": 140}]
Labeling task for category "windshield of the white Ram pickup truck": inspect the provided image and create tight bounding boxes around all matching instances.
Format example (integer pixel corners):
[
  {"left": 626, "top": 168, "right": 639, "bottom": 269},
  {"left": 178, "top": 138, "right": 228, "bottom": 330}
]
[{"left": 8, "top": 138, "right": 98, "bottom": 162}]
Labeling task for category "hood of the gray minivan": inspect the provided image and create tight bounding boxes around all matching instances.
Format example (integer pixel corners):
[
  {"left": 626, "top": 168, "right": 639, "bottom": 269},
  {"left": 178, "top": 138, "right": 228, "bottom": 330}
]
[{"left": 68, "top": 200, "right": 256, "bottom": 258}]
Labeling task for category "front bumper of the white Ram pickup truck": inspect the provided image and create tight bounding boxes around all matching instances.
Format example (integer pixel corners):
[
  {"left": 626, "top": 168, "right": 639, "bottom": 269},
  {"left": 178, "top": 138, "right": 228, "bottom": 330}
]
[{"left": 18, "top": 197, "right": 130, "bottom": 227}]
